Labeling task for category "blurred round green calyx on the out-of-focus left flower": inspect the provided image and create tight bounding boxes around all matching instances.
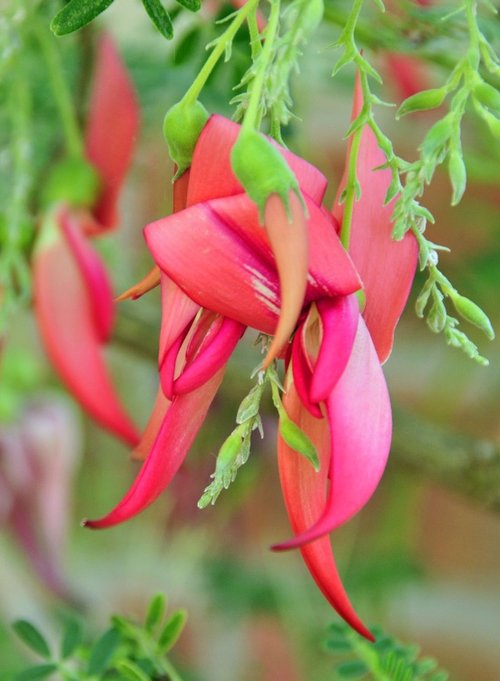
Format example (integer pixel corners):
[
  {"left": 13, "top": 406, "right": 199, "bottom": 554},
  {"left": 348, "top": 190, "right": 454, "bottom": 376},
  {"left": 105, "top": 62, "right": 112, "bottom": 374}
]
[{"left": 41, "top": 158, "right": 101, "bottom": 208}]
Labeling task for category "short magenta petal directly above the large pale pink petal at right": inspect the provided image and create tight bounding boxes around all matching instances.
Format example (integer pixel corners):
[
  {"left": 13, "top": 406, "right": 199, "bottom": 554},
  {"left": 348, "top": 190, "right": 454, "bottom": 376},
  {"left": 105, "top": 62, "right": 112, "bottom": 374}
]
[{"left": 310, "top": 295, "right": 359, "bottom": 402}]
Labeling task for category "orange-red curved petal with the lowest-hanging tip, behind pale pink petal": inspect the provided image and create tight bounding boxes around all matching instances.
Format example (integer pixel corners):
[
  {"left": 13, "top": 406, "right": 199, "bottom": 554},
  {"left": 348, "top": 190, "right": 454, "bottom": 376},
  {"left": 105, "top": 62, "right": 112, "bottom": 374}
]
[{"left": 272, "top": 374, "right": 373, "bottom": 640}]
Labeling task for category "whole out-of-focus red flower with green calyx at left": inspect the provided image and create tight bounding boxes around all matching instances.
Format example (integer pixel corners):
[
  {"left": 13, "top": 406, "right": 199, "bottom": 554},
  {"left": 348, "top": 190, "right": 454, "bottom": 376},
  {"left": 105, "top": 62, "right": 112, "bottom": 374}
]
[{"left": 33, "top": 36, "right": 139, "bottom": 445}]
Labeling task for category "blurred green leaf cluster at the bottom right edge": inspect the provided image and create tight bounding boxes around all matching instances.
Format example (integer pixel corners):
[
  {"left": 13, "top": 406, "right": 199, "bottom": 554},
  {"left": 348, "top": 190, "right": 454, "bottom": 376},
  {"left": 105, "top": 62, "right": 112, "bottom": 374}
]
[{"left": 325, "top": 623, "right": 448, "bottom": 681}]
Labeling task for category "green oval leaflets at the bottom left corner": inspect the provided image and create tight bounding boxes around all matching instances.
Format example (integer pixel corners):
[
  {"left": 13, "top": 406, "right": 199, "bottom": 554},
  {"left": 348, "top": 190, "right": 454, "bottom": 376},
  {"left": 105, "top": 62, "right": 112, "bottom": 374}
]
[{"left": 13, "top": 594, "right": 187, "bottom": 681}]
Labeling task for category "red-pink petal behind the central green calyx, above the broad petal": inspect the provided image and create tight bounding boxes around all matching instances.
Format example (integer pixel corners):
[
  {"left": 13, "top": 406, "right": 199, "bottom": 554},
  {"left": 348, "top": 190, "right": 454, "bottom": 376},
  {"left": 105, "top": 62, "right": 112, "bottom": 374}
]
[{"left": 187, "top": 115, "right": 327, "bottom": 206}]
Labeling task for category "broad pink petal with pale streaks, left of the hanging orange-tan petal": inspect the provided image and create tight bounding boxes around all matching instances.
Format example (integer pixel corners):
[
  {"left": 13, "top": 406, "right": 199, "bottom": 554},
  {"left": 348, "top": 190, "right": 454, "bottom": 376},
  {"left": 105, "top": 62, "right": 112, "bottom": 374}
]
[{"left": 145, "top": 203, "right": 280, "bottom": 334}]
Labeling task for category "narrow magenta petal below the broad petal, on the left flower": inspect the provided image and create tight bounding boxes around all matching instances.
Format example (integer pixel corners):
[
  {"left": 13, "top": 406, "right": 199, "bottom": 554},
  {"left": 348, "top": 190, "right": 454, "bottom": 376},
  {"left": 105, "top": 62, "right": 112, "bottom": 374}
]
[{"left": 173, "top": 317, "right": 246, "bottom": 395}]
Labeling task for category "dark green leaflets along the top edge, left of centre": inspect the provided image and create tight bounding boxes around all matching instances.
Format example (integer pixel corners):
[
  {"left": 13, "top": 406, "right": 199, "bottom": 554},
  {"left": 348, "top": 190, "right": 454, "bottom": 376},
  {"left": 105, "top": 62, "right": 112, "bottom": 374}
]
[{"left": 50, "top": 0, "right": 201, "bottom": 40}]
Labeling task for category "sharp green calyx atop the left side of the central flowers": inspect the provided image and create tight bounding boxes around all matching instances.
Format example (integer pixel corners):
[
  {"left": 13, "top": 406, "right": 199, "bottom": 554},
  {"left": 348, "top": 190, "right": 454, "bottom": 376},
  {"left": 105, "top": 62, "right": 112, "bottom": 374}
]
[{"left": 163, "top": 101, "right": 210, "bottom": 179}]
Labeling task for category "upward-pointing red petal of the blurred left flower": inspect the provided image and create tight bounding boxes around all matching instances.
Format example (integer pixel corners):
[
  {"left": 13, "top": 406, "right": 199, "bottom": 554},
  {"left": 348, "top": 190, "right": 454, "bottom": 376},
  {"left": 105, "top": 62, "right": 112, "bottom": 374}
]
[{"left": 85, "top": 34, "right": 139, "bottom": 228}]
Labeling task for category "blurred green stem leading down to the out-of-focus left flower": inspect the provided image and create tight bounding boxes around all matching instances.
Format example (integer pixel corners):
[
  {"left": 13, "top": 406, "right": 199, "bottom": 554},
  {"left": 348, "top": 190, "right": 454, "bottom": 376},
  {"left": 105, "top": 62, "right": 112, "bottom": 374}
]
[{"left": 33, "top": 20, "right": 84, "bottom": 158}]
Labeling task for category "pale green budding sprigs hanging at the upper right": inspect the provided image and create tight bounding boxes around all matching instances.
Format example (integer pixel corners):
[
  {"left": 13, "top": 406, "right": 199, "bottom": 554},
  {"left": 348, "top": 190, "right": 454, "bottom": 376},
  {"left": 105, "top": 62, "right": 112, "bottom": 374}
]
[{"left": 326, "top": 0, "right": 500, "bottom": 365}]
